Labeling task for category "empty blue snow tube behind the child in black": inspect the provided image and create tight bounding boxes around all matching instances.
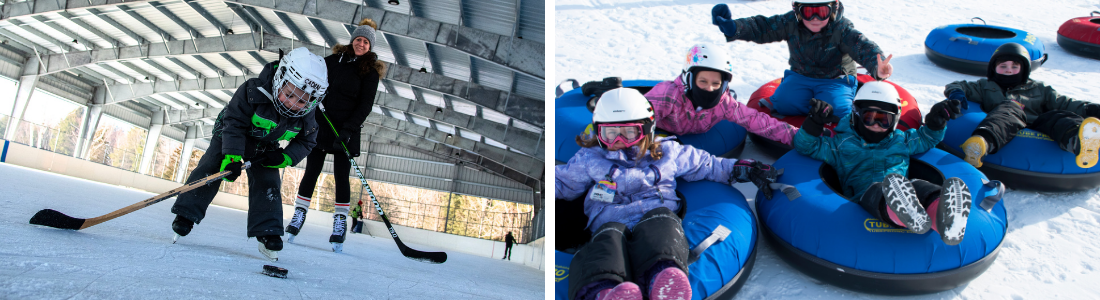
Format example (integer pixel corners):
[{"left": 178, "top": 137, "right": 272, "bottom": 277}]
[{"left": 924, "top": 18, "right": 1047, "bottom": 77}]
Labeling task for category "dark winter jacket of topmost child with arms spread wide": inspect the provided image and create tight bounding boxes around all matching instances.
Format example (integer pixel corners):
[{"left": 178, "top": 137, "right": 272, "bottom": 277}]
[{"left": 726, "top": 4, "right": 886, "bottom": 79}]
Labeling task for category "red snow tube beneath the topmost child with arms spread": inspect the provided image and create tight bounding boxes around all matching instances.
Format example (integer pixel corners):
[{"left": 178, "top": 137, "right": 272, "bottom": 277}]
[{"left": 748, "top": 74, "right": 924, "bottom": 157}]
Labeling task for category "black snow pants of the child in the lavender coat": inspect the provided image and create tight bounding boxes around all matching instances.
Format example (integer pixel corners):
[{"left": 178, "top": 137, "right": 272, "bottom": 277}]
[{"left": 569, "top": 208, "right": 690, "bottom": 299}]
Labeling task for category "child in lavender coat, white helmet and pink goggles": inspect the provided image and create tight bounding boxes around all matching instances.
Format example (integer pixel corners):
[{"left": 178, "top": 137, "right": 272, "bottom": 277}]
[{"left": 554, "top": 88, "right": 778, "bottom": 299}]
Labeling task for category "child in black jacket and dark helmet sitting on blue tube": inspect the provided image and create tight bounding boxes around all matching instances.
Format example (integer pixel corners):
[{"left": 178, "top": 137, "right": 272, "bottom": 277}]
[{"left": 944, "top": 43, "right": 1100, "bottom": 168}]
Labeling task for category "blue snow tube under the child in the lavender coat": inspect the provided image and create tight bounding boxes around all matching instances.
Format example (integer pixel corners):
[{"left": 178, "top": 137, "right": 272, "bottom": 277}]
[{"left": 554, "top": 180, "right": 758, "bottom": 300}]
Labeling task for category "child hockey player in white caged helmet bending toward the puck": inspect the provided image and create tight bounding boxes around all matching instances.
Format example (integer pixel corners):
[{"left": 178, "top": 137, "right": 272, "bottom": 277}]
[{"left": 172, "top": 47, "right": 329, "bottom": 260}]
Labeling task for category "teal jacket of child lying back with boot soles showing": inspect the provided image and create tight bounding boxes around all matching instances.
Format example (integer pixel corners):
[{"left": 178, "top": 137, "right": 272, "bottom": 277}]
[{"left": 794, "top": 114, "right": 946, "bottom": 199}]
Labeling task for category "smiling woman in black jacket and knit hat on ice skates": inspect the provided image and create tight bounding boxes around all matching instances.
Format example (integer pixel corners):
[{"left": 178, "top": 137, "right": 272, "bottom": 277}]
[{"left": 286, "top": 19, "right": 386, "bottom": 253}]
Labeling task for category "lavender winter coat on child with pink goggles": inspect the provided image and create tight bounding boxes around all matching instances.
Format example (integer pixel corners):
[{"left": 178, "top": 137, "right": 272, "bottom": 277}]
[{"left": 554, "top": 137, "right": 737, "bottom": 230}]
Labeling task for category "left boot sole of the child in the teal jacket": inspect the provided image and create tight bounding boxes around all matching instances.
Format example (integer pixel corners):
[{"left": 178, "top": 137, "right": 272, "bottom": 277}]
[{"left": 882, "top": 174, "right": 932, "bottom": 234}]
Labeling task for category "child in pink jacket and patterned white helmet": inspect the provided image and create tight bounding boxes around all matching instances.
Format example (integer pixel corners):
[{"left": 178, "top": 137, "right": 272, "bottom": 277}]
[{"left": 646, "top": 44, "right": 799, "bottom": 145}]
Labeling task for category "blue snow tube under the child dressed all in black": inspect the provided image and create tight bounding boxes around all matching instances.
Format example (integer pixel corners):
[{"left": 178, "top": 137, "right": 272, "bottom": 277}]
[{"left": 937, "top": 102, "right": 1100, "bottom": 191}]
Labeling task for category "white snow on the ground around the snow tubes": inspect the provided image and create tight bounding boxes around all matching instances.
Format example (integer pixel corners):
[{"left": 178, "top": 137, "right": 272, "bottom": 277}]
[{"left": 558, "top": 0, "right": 1100, "bottom": 299}]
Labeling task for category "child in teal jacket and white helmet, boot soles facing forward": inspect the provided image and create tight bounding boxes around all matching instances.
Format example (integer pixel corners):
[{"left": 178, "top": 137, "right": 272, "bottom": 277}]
[{"left": 794, "top": 81, "right": 970, "bottom": 245}]
